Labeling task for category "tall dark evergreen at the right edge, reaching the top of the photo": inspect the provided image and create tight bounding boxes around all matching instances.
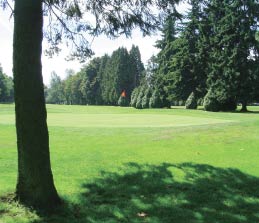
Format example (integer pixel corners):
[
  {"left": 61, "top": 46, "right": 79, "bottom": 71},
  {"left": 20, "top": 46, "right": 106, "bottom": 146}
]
[{"left": 205, "top": 0, "right": 258, "bottom": 110}]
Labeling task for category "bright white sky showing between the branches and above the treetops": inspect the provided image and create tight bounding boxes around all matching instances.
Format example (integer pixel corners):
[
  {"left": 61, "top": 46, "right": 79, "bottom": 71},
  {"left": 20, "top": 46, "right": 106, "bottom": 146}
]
[{"left": 0, "top": 4, "right": 187, "bottom": 85}]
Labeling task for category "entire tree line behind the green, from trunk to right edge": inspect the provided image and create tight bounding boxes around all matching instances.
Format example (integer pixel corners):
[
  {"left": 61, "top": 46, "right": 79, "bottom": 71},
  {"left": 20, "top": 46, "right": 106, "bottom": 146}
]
[{"left": 47, "top": 0, "right": 259, "bottom": 111}]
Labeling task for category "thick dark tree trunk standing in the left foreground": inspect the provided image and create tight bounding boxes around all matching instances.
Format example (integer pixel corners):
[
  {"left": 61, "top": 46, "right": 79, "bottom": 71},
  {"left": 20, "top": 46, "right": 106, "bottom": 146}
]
[{"left": 13, "top": 0, "right": 60, "bottom": 208}]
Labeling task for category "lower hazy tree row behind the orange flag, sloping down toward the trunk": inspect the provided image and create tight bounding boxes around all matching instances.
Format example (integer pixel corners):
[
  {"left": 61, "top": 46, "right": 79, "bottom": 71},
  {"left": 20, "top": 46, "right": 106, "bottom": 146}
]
[{"left": 45, "top": 45, "right": 145, "bottom": 106}]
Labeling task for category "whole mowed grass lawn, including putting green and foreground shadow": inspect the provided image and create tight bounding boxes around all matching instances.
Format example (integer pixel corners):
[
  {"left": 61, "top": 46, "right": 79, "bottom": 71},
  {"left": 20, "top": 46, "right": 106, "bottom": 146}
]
[{"left": 0, "top": 105, "right": 259, "bottom": 223}]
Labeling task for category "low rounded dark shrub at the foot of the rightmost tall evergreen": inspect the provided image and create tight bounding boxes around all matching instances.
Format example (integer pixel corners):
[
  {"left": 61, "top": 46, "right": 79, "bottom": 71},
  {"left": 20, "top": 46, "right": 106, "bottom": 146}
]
[{"left": 203, "top": 89, "right": 237, "bottom": 112}]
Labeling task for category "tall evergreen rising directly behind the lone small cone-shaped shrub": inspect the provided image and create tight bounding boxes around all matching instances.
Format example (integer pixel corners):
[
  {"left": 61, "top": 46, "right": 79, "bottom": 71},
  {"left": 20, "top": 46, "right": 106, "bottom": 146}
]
[{"left": 169, "top": 0, "right": 207, "bottom": 101}]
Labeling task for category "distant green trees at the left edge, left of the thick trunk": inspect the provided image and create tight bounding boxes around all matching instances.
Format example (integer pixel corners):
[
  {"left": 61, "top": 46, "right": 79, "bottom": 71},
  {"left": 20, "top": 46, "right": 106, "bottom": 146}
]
[{"left": 0, "top": 64, "right": 14, "bottom": 103}]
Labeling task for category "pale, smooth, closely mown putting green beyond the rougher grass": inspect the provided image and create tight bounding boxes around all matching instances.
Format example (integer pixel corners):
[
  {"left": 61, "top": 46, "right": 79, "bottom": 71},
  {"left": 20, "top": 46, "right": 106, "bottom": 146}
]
[{"left": 0, "top": 113, "right": 234, "bottom": 128}]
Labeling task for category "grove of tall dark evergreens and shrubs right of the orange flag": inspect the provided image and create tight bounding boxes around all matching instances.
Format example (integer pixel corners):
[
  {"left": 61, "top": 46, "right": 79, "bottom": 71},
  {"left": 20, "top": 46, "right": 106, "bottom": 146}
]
[{"left": 131, "top": 0, "right": 259, "bottom": 111}]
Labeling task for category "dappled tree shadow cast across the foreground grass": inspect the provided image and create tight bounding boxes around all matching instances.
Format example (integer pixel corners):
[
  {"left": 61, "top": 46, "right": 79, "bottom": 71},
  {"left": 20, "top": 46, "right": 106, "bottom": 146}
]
[{"left": 33, "top": 163, "right": 259, "bottom": 223}]
